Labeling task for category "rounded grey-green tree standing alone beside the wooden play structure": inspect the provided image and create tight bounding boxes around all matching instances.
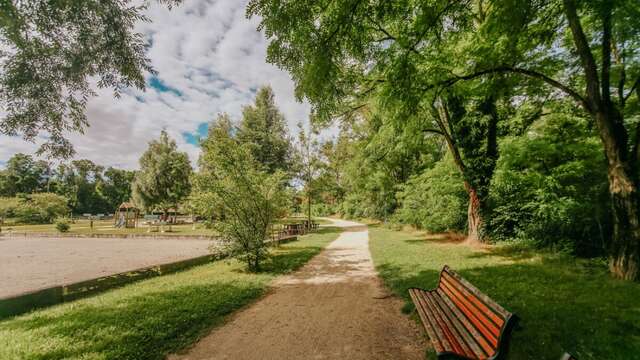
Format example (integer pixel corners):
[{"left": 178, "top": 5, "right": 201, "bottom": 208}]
[{"left": 131, "top": 130, "right": 192, "bottom": 219}]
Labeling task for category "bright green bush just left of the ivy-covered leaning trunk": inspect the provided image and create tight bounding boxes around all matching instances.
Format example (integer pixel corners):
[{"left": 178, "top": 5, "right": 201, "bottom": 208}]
[{"left": 393, "top": 156, "right": 468, "bottom": 232}]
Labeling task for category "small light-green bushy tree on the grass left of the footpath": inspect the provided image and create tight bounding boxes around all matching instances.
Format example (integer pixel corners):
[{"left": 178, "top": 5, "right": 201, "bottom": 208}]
[{"left": 192, "top": 117, "right": 288, "bottom": 271}]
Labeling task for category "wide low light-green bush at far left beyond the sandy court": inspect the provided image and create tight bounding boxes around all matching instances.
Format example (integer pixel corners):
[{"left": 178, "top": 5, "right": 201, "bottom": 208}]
[{"left": 13, "top": 193, "right": 69, "bottom": 224}]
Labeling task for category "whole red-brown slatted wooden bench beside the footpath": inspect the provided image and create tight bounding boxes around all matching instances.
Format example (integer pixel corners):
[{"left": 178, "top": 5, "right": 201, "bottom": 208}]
[{"left": 409, "top": 265, "right": 517, "bottom": 359}]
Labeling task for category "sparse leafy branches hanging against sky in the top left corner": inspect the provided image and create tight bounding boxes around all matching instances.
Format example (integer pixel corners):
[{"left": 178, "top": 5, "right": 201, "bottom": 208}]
[{"left": 0, "top": 0, "right": 180, "bottom": 157}]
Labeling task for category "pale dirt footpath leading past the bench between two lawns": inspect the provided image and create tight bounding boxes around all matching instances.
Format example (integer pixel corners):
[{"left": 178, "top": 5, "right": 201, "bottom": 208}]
[{"left": 169, "top": 221, "right": 425, "bottom": 360}]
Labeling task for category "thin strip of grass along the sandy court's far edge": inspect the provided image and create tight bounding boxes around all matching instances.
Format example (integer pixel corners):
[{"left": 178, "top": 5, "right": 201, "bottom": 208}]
[{"left": 2, "top": 220, "right": 215, "bottom": 236}]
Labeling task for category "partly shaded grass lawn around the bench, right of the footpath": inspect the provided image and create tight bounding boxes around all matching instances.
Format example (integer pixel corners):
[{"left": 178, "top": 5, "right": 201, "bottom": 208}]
[{"left": 369, "top": 227, "right": 640, "bottom": 360}]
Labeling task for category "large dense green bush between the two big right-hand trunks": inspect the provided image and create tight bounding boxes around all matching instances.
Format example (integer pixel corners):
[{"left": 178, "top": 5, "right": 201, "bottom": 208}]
[{"left": 489, "top": 114, "right": 610, "bottom": 256}]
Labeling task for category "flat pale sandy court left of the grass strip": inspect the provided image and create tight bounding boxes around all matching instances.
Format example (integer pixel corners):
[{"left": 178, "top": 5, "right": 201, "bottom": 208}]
[{"left": 0, "top": 237, "right": 215, "bottom": 298}]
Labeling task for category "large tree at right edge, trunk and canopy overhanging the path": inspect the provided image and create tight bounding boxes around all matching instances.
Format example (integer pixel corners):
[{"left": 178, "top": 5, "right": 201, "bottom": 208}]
[{"left": 247, "top": 0, "right": 640, "bottom": 279}]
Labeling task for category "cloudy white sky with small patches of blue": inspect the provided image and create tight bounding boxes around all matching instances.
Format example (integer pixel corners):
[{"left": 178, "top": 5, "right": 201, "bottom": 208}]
[{"left": 0, "top": 0, "right": 310, "bottom": 169}]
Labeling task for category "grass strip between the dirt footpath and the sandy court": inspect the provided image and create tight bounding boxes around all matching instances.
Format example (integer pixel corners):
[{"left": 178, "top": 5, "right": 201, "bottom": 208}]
[{"left": 0, "top": 228, "right": 339, "bottom": 360}]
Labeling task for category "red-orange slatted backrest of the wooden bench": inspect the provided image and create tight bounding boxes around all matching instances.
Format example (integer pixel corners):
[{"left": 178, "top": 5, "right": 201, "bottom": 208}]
[{"left": 437, "top": 266, "right": 512, "bottom": 358}]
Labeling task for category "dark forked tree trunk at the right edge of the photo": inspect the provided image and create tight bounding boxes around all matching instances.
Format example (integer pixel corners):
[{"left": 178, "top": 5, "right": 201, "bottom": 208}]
[{"left": 563, "top": 0, "right": 640, "bottom": 280}]
